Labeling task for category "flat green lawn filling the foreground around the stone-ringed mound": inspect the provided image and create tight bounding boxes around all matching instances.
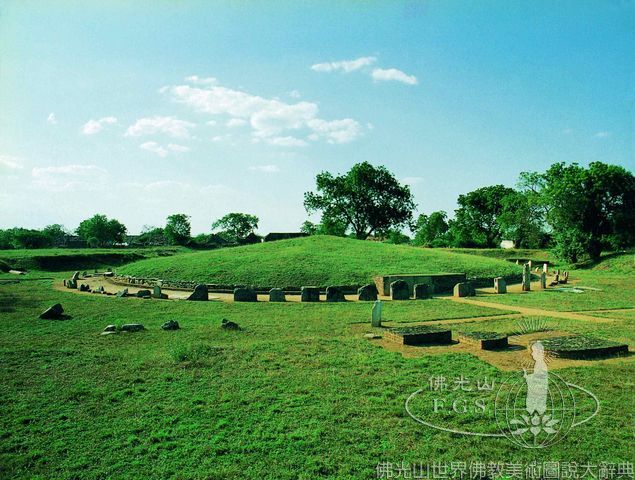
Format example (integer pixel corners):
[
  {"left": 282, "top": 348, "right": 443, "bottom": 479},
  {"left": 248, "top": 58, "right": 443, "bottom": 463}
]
[{"left": 0, "top": 244, "right": 635, "bottom": 479}]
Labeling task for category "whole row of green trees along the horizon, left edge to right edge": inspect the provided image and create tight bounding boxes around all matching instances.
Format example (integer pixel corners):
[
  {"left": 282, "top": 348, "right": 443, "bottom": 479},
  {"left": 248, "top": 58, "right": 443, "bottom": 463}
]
[{"left": 0, "top": 162, "right": 635, "bottom": 263}]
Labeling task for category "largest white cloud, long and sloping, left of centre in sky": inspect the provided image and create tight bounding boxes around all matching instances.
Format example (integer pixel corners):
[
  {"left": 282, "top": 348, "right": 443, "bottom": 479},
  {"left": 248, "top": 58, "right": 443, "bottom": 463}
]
[{"left": 164, "top": 79, "right": 363, "bottom": 146}]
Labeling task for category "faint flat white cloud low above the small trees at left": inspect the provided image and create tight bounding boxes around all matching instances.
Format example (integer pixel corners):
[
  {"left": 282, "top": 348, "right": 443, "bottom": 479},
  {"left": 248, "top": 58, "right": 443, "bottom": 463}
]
[{"left": 31, "top": 164, "right": 108, "bottom": 192}]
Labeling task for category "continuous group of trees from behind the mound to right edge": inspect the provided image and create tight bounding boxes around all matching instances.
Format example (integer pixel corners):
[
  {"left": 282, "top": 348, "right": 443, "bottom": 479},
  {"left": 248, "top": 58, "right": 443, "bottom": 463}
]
[{"left": 302, "top": 162, "right": 635, "bottom": 263}]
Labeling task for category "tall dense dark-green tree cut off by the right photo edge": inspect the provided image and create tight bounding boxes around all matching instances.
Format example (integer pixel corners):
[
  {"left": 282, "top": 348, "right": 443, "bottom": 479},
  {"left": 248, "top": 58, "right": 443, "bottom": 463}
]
[{"left": 525, "top": 162, "right": 635, "bottom": 262}]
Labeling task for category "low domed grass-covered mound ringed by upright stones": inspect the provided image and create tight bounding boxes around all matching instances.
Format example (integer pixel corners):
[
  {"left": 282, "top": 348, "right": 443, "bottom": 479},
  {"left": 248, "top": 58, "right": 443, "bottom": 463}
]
[{"left": 117, "top": 236, "right": 520, "bottom": 287}]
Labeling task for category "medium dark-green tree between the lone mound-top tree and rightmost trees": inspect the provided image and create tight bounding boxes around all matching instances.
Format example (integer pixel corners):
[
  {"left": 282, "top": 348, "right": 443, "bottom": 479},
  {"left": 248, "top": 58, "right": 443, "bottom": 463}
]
[{"left": 452, "top": 185, "right": 516, "bottom": 248}]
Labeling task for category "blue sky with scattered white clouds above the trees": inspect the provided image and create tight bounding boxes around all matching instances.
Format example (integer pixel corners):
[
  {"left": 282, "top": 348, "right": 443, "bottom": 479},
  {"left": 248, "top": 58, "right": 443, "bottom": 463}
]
[{"left": 0, "top": 0, "right": 635, "bottom": 233}]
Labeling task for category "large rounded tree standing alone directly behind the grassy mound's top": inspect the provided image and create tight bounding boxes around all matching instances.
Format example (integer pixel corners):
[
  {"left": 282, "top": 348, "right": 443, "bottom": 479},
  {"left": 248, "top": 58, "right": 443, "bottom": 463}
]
[{"left": 304, "top": 162, "right": 416, "bottom": 239}]
